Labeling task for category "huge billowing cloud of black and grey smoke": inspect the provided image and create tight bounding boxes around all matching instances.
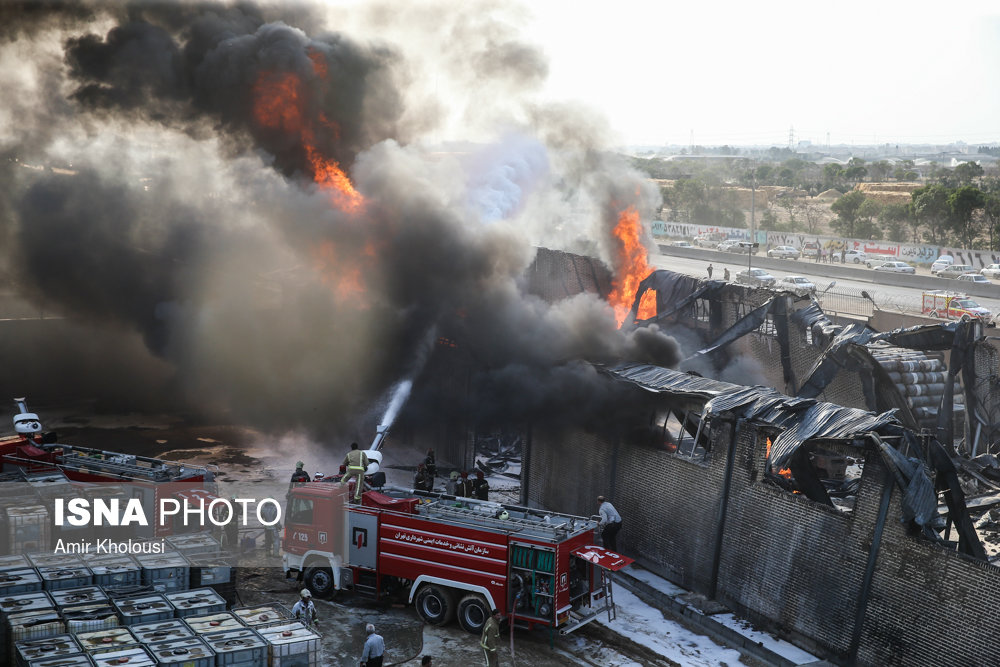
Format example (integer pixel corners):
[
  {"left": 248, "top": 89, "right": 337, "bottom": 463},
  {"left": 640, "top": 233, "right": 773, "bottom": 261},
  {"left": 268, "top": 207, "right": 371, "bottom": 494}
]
[{"left": 0, "top": 2, "right": 677, "bottom": 433}]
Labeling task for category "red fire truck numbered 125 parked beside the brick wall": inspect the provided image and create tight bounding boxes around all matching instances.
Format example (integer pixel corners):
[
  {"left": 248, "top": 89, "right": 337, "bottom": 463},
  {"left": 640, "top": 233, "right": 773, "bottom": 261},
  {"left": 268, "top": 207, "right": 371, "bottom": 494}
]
[{"left": 282, "top": 483, "right": 632, "bottom": 634}]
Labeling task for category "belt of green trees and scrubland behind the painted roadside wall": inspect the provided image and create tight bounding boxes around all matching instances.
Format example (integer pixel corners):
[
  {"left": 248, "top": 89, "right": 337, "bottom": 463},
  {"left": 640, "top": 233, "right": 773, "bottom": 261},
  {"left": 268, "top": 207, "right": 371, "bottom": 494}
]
[{"left": 633, "top": 154, "right": 1000, "bottom": 250}]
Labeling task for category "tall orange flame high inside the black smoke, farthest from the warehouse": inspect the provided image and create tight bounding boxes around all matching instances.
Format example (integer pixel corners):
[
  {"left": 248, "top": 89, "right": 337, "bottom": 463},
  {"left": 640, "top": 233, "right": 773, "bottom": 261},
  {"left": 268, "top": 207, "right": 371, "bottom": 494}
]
[{"left": 253, "top": 66, "right": 364, "bottom": 213}]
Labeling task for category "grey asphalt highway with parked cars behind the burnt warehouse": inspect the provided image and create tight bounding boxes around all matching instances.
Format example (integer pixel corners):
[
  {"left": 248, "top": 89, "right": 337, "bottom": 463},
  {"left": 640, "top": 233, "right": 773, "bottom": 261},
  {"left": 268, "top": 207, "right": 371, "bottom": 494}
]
[{"left": 649, "top": 247, "right": 1000, "bottom": 315}]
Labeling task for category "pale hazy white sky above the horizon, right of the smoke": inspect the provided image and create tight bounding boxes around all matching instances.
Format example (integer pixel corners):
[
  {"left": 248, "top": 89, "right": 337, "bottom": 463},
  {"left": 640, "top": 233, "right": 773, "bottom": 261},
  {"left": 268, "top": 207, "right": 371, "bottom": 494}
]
[{"left": 525, "top": 0, "right": 1000, "bottom": 145}]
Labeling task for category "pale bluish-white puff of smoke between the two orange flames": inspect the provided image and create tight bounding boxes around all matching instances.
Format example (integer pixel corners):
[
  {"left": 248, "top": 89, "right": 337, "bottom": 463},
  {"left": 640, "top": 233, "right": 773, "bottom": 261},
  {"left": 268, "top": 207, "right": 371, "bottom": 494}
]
[{"left": 463, "top": 134, "right": 549, "bottom": 222}]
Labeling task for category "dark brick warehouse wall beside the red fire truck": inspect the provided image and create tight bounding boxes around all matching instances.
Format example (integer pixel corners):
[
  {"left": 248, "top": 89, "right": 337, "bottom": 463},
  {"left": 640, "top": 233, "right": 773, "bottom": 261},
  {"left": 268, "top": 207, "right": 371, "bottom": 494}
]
[{"left": 528, "top": 418, "right": 1000, "bottom": 666}]
